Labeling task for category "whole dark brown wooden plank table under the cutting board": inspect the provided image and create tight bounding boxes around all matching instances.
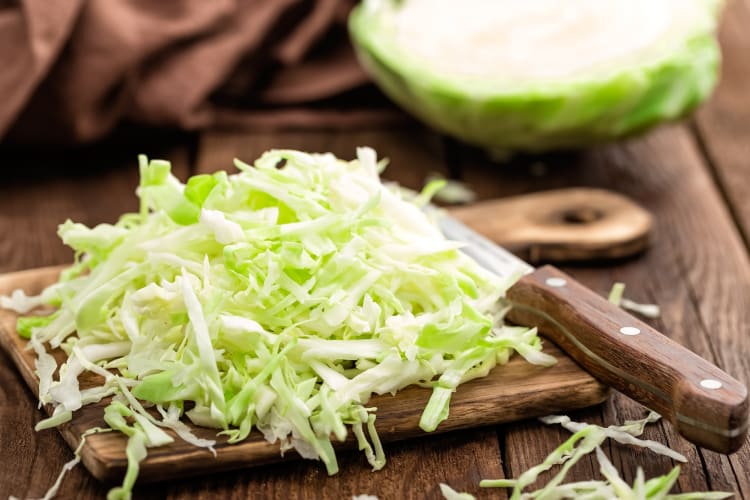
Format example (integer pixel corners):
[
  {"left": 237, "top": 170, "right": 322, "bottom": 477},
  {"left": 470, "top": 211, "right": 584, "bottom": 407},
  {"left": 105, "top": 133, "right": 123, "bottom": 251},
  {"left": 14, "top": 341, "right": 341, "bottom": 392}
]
[{"left": 0, "top": 0, "right": 750, "bottom": 499}]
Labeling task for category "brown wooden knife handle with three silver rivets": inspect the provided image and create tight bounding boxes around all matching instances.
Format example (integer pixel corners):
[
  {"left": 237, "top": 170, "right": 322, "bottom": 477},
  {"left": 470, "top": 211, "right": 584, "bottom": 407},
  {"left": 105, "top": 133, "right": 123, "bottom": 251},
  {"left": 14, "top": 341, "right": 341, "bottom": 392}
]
[{"left": 507, "top": 266, "right": 748, "bottom": 453}]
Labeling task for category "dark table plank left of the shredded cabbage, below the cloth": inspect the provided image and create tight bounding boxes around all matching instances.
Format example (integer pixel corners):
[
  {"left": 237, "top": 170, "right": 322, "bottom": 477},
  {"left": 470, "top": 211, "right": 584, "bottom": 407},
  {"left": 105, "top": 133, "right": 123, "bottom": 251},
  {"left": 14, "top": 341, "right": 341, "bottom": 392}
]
[{"left": 0, "top": 149, "right": 188, "bottom": 272}]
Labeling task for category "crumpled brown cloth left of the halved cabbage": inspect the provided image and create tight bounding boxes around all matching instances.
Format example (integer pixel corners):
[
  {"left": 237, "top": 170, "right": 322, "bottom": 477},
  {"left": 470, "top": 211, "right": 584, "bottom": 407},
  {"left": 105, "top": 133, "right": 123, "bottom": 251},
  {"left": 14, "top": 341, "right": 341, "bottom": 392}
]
[{"left": 0, "top": 0, "right": 396, "bottom": 143}]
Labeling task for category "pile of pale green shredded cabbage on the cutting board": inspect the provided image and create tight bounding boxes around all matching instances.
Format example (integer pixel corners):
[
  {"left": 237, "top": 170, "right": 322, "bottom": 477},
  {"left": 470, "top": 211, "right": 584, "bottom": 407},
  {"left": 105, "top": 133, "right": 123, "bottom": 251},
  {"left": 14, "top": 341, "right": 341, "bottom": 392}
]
[{"left": 1, "top": 148, "right": 554, "bottom": 498}]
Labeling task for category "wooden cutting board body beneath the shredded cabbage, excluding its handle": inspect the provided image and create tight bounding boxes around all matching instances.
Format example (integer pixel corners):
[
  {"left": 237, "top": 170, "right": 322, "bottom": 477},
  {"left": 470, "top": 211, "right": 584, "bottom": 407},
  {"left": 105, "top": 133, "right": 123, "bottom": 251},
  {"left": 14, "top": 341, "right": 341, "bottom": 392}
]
[{"left": 0, "top": 267, "right": 609, "bottom": 482}]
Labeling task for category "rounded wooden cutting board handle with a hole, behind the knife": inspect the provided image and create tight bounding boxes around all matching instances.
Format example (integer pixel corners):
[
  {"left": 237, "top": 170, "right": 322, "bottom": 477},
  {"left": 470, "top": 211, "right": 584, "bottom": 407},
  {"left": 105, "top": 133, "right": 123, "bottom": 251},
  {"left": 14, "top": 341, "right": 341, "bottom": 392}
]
[{"left": 450, "top": 188, "right": 653, "bottom": 263}]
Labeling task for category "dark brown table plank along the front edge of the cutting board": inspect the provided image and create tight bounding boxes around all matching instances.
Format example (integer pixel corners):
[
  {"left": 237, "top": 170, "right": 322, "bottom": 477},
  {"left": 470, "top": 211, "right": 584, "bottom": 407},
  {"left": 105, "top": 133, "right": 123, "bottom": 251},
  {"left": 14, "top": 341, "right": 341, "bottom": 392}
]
[{"left": 129, "top": 429, "right": 508, "bottom": 500}]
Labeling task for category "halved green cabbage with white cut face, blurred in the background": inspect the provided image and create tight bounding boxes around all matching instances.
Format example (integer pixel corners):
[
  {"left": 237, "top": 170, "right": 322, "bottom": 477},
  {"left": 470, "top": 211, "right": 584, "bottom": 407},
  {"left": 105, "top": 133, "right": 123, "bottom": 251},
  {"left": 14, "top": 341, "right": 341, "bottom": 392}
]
[{"left": 349, "top": 0, "right": 721, "bottom": 152}]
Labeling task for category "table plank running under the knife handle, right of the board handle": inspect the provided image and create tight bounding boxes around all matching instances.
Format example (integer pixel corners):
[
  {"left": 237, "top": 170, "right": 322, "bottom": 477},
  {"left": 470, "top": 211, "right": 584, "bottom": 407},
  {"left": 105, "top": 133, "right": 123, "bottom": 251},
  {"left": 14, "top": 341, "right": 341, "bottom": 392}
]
[{"left": 452, "top": 126, "right": 750, "bottom": 495}]
